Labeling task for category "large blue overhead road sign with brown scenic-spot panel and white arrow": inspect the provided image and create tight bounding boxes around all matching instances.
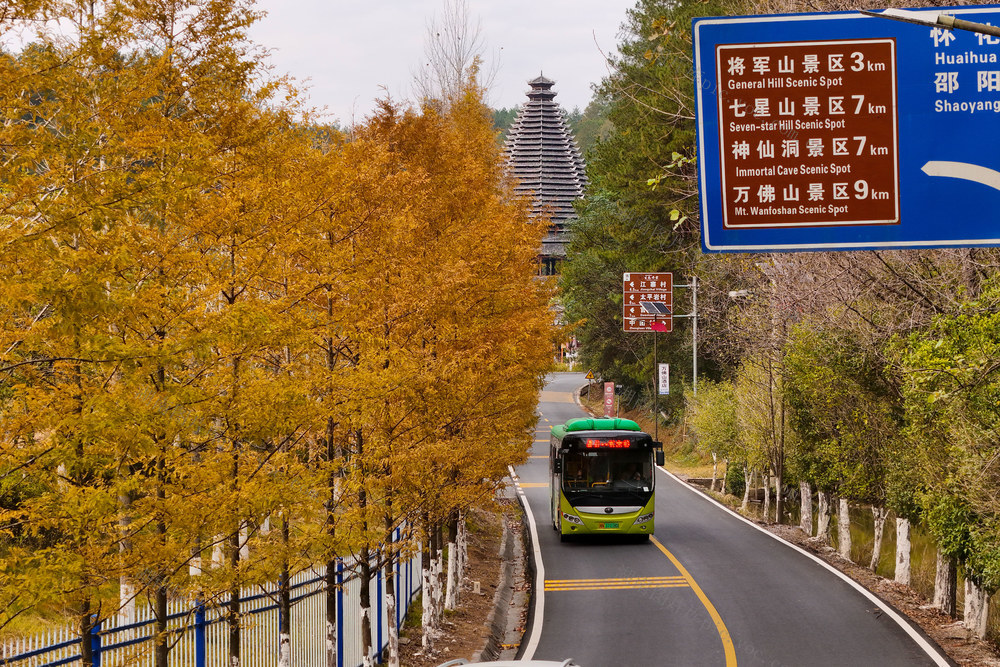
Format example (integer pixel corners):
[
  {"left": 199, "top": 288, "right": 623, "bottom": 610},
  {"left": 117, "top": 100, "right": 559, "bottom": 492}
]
[{"left": 692, "top": 5, "right": 1000, "bottom": 252}]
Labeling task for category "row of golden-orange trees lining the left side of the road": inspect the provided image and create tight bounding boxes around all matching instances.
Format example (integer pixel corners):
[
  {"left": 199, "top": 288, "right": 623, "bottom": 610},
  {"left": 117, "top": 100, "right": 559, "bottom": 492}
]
[{"left": 0, "top": 0, "right": 553, "bottom": 665}]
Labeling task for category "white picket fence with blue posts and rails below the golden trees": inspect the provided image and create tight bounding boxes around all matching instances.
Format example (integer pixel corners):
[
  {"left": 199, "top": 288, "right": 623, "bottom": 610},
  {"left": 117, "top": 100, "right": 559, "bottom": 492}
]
[{"left": 0, "top": 554, "right": 421, "bottom": 667}]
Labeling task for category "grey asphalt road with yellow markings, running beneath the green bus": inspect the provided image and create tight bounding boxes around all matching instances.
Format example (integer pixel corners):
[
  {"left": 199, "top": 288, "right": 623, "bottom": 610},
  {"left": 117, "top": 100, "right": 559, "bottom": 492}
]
[{"left": 516, "top": 373, "right": 949, "bottom": 667}]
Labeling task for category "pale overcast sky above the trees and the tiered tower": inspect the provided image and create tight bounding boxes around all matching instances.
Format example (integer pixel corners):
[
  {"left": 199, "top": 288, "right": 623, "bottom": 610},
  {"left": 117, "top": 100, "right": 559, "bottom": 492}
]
[{"left": 250, "top": 0, "right": 636, "bottom": 125}]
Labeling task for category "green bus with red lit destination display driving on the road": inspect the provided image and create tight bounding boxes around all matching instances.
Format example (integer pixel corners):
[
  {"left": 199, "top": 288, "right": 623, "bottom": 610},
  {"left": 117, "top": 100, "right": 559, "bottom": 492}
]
[{"left": 549, "top": 418, "right": 663, "bottom": 542}]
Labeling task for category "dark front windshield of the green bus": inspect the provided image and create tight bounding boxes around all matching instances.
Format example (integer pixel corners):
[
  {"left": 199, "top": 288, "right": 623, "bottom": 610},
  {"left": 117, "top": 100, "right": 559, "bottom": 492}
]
[{"left": 562, "top": 449, "right": 653, "bottom": 491}]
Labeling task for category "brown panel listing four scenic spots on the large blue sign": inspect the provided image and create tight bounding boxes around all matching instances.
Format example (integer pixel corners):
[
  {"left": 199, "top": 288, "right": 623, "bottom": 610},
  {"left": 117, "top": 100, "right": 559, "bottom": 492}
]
[{"left": 716, "top": 39, "right": 899, "bottom": 229}]
